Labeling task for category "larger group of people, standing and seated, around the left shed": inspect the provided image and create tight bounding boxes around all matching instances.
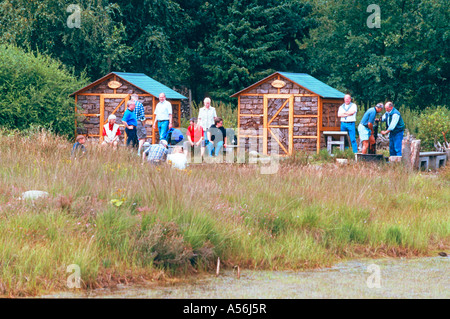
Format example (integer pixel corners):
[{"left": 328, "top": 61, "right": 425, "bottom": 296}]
[{"left": 72, "top": 93, "right": 227, "bottom": 168}]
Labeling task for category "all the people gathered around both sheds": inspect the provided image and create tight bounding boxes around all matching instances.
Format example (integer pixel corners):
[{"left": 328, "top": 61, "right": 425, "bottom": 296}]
[{"left": 72, "top": 93, "right": 405, "bottom": 162}]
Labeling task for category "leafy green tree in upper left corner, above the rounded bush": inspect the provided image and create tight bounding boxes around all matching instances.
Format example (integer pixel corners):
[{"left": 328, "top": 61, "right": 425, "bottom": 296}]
[{"left": 0, "top": 0, "right": 131, "bottom": 79}]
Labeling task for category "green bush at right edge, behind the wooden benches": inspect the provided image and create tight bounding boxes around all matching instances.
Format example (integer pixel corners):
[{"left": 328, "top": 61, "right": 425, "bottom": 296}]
[{"left": 417, "top": 106, "right": 450, "bottom": 151}]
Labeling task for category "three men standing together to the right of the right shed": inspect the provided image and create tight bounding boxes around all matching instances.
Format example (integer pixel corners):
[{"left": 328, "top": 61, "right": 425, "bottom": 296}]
[{"left": 338, "top": 94, "right": 405, "bottom": 156}]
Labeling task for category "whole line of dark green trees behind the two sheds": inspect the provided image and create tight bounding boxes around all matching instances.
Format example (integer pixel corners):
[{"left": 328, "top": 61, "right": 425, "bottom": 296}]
[{"left": 0, "top": 0, "right": 450, "bottom": 109}]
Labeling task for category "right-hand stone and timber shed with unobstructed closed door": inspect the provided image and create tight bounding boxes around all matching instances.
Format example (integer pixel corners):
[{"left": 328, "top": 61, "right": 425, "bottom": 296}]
[{"left": 232, "top": 72, "right": 345, "bottom": 155}]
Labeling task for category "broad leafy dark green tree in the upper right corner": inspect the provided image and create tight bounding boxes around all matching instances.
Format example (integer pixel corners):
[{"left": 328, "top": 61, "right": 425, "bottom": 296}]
[{"left": 299, "top": 0, "right": 450, "bottom": 108}]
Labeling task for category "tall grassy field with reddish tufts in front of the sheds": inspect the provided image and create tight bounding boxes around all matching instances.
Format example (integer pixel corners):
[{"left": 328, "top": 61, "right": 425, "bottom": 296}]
[{"left": 0, "top": 131, "right": 450, "bottom": 297}]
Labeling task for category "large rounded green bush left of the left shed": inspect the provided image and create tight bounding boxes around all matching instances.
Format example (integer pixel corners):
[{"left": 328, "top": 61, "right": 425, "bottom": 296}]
[{"left": 0, "top": 45, "right": 87, "bottom": 137}]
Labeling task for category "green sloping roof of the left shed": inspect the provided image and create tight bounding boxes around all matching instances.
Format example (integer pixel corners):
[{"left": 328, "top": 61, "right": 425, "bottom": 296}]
[{"left": 112, "top": 72, "right": 187, "bottom": 99}]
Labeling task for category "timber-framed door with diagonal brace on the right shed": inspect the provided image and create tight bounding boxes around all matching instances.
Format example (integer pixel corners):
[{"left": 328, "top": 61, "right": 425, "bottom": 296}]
[{"left": 263, "top": 94, "right": 294, "bottom": 155}]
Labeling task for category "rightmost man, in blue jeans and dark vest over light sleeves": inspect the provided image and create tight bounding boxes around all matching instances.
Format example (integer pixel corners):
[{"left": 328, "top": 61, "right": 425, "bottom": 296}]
[{"left": 381, "top": 102, "right": 405, "bottom": 156}]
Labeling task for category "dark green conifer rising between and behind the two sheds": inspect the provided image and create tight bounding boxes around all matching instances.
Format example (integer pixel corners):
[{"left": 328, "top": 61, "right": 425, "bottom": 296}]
[{"left": 202, "top": 0, "right": 309, "bottom": 101}]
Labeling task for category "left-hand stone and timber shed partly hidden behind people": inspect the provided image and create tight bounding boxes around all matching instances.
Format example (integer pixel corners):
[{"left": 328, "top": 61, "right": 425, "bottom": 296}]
[{"left": 70, "top": 72, "right": 186, "bottom": 143}]
